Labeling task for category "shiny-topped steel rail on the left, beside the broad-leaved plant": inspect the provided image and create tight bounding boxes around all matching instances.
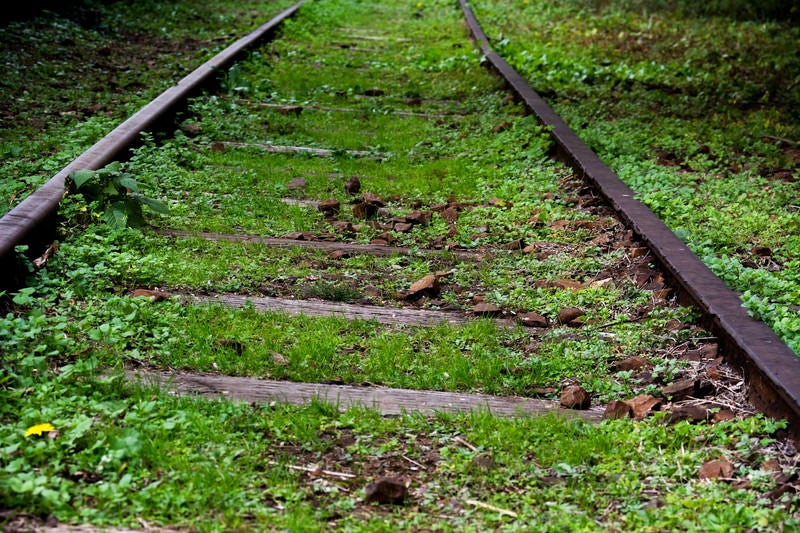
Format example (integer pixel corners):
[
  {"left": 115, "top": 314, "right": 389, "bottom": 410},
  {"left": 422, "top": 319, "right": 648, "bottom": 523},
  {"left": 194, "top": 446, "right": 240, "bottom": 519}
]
[{"left": 0, "top": 0, "right": 305, "bottom": 260}]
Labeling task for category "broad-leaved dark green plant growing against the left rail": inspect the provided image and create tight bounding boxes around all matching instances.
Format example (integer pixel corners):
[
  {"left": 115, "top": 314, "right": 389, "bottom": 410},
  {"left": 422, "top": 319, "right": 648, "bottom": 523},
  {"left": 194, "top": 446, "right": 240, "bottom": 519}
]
[{"left": 69, "top": 162, "right": 169, "bottom": 228}]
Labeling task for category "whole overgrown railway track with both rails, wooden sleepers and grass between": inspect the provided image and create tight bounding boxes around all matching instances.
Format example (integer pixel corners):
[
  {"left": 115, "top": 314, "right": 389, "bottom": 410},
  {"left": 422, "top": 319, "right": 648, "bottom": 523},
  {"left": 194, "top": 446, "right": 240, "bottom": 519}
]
[{"left": 0, "top": 0, "right": 800, "bottom": 530}]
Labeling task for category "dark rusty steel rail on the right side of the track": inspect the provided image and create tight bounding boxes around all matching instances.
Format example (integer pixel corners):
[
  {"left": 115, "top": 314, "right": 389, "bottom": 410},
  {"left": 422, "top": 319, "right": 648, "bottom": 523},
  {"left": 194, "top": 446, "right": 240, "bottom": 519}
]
[{"left": 459, "top": 0, "right": 800, "bottom": 434}]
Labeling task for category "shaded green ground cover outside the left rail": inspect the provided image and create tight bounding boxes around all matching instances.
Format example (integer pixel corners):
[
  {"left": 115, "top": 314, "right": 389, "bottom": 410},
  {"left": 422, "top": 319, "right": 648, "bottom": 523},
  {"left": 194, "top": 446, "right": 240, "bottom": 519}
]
[{"left": 0, "top": 0, "right": 290, "bottom": 215}]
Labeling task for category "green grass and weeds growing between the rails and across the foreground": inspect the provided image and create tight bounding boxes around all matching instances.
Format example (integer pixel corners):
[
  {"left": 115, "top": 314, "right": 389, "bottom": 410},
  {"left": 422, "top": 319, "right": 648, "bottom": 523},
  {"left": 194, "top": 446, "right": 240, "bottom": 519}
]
[{"left": 0, "top": 0, "right": 800, "bottom": 531}]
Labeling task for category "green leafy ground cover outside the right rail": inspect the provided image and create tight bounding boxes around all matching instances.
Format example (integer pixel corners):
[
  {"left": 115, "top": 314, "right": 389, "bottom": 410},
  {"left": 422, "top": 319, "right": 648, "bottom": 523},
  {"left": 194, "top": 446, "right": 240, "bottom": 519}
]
[{"left": 474, "top": 1, "right": 800, "bottom": 352}]
